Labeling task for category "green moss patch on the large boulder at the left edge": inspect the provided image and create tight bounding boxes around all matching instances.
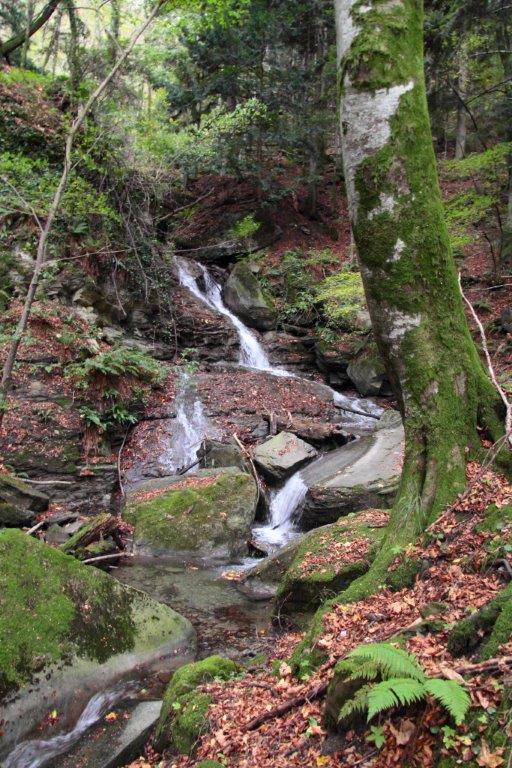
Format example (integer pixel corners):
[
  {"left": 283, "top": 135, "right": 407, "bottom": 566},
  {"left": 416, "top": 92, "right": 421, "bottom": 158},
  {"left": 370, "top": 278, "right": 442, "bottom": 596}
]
[{"left": 0, "top": 530, "right": 135, "bottom": 694}]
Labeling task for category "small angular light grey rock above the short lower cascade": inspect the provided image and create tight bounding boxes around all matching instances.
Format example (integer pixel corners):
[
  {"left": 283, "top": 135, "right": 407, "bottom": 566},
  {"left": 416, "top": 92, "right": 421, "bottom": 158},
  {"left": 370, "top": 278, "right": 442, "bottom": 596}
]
[{"left": 253, "top": 432, "right": 317, "bottom": 480}]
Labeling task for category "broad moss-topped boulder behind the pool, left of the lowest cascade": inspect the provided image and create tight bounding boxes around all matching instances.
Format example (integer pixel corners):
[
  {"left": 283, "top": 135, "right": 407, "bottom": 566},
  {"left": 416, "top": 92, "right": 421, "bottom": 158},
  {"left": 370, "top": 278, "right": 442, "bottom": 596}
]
[{"left": 125, "top": 469, "right": 256, "bottom": 551}]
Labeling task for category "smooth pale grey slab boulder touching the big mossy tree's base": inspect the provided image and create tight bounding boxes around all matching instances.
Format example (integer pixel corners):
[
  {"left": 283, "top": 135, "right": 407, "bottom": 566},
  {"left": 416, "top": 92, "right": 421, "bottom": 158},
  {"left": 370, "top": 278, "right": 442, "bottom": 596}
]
[{"left": 301, "top": 411, "right": 404, "bottom": 530}]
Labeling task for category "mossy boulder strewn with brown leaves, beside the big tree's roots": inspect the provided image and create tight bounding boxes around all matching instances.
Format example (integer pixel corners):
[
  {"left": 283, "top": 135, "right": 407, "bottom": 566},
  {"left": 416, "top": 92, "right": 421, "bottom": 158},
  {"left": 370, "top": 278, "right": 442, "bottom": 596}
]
[{"left": 274, "top": 509, "right": 388, "bottom": 626}]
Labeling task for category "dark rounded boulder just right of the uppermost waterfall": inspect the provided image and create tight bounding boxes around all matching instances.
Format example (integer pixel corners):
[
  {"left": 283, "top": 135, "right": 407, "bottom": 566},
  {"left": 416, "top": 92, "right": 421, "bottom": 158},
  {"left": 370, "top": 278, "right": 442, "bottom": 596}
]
[{"left": 222, "top": 261, "right": 276, "bottom": 331}]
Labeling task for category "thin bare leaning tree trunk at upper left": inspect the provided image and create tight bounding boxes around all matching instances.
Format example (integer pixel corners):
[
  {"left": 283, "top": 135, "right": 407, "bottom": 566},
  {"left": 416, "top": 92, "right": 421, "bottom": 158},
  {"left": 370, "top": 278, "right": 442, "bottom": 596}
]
[{"left": 0, "top": 0, "right": 166, "bottom": 426}]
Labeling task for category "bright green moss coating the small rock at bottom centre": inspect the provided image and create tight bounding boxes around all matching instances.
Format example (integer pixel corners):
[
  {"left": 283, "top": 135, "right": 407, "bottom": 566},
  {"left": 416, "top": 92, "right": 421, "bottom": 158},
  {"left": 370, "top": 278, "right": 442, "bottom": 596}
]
[{"left": 155, "top": 656, "right": 238, "bottom": 753}]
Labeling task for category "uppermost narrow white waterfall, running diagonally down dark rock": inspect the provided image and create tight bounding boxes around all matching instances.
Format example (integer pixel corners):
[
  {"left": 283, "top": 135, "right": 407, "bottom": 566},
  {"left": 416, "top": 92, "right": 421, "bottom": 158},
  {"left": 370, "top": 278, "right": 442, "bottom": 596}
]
[{"left": 178, "top": 261, "right": 286, "bottom": 376}]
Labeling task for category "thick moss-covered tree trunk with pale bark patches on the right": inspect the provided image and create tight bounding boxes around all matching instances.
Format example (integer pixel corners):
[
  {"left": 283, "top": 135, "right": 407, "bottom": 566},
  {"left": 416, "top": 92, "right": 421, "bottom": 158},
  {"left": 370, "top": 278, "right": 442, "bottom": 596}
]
[{"left": 335, "top": 0, "right": 503, "bottom": 599}]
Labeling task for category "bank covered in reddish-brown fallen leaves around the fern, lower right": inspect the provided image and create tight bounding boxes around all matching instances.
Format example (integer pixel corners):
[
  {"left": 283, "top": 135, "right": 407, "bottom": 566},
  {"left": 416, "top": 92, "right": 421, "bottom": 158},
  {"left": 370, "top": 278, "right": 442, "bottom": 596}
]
[{"left": 125, "top": 464, "right": 512, "bottom": 768}]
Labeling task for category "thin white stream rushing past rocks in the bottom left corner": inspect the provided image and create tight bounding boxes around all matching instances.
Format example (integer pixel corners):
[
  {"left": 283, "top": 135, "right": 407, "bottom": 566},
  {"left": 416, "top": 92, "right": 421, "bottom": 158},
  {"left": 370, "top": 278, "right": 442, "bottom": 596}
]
[{"left": 2, "top": 683, "right": 138, "bottom": 768}]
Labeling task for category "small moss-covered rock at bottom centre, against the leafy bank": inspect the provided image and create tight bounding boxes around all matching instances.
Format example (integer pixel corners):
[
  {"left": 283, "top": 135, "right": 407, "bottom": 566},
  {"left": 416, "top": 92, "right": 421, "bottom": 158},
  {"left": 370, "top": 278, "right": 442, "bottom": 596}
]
[{"left": 155, "top": 656, "right": 238, "bottom": 754}]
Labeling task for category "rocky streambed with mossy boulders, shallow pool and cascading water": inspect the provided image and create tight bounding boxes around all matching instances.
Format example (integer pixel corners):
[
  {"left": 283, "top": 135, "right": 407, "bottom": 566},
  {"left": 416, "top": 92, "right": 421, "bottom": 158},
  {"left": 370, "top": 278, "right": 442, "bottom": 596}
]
[{"left": 0, "top": 256, "right": 403, "bottom": 768}]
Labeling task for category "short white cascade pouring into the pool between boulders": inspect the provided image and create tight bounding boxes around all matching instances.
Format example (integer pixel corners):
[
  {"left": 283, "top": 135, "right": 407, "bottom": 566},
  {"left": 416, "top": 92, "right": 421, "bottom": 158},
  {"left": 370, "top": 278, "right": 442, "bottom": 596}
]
[{"left": 254, "top": 472, "right": 308, "bottom": 546}]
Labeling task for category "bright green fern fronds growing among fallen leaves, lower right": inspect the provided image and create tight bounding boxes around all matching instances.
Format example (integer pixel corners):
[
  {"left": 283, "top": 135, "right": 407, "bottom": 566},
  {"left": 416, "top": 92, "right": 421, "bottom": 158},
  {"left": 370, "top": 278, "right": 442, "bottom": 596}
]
[{"left": 336, "top": 643, "right": 471, "bottom": 725}]
